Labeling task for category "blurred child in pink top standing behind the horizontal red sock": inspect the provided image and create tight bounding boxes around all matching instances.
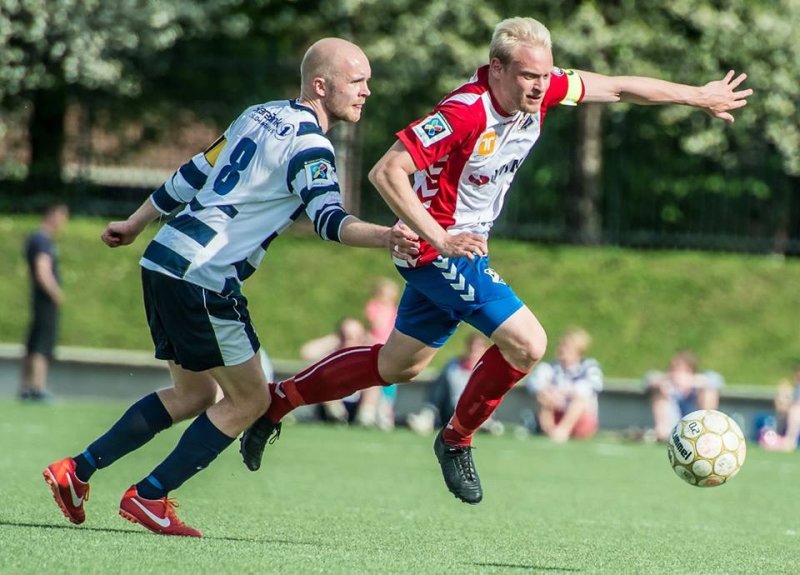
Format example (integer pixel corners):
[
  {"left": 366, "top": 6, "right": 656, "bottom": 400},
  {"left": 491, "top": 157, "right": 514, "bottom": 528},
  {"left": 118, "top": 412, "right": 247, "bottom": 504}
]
[{"left": 358, "top": 278, "right": 400, "bottom": 430}]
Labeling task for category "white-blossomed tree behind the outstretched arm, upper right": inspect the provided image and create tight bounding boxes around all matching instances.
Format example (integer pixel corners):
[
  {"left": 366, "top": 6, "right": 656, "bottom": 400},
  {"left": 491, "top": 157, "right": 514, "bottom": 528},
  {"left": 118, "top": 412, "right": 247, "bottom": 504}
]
[{"left": 504, "top": 0, "right": 800, "bottom": 243}]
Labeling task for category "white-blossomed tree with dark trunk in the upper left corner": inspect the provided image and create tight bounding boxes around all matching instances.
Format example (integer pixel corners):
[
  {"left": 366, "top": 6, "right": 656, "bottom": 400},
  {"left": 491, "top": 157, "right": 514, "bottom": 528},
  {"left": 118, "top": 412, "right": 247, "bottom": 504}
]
[{"left": 0, "top": 0, "right": 238, "bottom": 185}]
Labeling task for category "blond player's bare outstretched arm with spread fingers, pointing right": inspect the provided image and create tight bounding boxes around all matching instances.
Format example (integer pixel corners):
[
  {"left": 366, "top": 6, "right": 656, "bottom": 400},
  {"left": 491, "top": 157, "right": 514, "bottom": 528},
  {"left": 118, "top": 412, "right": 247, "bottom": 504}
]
[{"left": 578, "top": 70, "right": 753, "bottom": 122}]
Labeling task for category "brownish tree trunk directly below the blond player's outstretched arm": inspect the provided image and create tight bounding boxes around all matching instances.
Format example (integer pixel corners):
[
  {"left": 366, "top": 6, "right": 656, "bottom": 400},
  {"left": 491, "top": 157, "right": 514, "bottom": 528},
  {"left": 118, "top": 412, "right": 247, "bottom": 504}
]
[{"left": 566, "top": 104, "right": 603, "bottom": 244}]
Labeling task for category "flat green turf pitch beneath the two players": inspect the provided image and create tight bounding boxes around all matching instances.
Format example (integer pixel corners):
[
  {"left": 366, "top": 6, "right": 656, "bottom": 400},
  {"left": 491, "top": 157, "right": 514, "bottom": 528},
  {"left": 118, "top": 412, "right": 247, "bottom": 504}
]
[{"left": 0, "top": 399, "right": 800, "bottom": 575}]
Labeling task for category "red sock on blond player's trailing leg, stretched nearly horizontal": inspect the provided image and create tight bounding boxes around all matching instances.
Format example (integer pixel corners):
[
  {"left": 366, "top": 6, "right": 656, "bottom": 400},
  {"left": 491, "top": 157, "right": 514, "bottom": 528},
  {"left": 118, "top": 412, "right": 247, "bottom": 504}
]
[{"left": 266, "top": 344, "right": 387, "bottom": 423}]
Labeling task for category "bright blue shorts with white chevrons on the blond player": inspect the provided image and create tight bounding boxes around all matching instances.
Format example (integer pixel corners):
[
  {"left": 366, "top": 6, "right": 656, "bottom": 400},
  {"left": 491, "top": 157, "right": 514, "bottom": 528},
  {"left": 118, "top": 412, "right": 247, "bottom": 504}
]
[{"left": 395, "top": 256, "right": 523, "bottom": 347}]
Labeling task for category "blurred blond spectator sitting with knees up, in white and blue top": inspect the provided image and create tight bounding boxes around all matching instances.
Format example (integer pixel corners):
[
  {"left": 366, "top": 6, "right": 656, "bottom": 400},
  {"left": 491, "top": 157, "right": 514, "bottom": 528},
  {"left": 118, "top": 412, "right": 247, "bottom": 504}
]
[{"left": 525, "top": 328, "right": 603, "bottom": 443}]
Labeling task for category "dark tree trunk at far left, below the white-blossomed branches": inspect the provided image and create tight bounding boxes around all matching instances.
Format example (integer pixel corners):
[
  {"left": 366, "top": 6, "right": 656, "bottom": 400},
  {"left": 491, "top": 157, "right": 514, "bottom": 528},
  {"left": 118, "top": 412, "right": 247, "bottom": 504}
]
[{"left": 28, "top": 87, "right": 67, "bottom": 189}]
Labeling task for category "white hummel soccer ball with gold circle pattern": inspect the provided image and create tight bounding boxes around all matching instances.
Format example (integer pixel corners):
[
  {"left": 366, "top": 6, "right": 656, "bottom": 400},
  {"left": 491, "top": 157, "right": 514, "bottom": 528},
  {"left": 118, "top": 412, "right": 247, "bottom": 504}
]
[{"left": 667, "top": 409, "right": 747, "bottom": 487}]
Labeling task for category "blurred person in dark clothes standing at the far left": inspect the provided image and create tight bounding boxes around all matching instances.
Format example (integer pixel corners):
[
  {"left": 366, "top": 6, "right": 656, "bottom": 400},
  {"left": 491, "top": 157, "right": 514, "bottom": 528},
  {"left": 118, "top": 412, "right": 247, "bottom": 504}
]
[{"left": 19, "top": 204, "right": 69, "bottom": 401}]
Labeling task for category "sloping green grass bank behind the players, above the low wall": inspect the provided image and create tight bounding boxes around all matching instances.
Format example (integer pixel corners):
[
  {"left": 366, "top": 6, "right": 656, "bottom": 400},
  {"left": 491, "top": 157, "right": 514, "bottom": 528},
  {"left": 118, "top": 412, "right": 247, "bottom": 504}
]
[{"left": 0, "top": 217, "right": 800, "bottom": 386}]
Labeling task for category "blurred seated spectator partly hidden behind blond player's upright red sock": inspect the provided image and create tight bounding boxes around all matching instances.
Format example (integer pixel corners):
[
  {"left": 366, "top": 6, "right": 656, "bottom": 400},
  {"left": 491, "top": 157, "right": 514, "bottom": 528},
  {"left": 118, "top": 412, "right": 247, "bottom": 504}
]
[{"left": 407, "top": 333, "right": 503, "bottom": 435}]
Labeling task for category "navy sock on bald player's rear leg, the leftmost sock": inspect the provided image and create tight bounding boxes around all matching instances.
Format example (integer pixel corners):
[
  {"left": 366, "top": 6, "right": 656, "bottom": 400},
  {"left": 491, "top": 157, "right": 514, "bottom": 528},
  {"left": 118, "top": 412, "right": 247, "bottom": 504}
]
[{"left": 74, "top": 393, "right": 172, "bottom": 481}]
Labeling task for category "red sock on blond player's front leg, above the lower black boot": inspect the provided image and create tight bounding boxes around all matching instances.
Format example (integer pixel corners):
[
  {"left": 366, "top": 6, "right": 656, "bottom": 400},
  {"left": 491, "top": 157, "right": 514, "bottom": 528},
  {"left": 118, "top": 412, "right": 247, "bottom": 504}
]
[{"left": 442, "top": 345, "right": 525, "bottom": 447}]
